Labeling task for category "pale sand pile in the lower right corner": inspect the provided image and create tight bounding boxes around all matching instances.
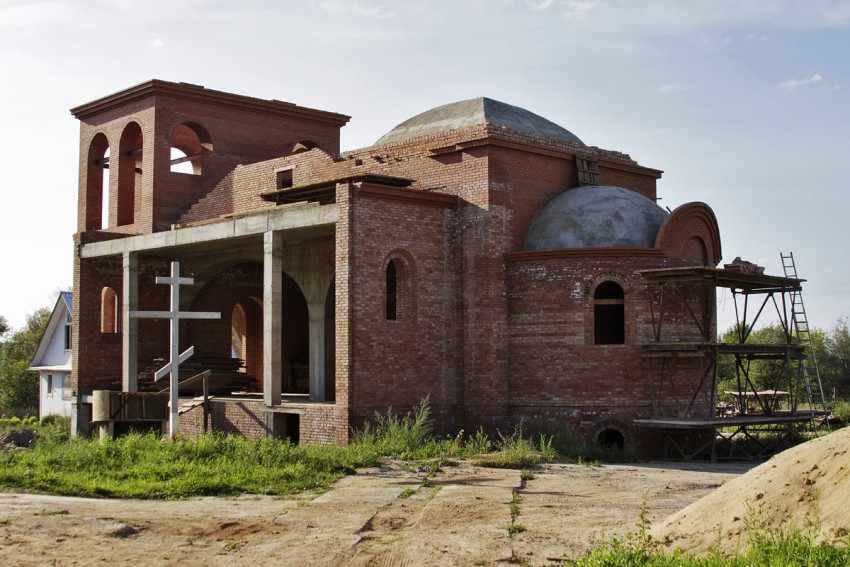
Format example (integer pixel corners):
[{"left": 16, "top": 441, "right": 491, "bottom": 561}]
[{"left": 651, "top": 428, "right": 850, "bottom": 554}]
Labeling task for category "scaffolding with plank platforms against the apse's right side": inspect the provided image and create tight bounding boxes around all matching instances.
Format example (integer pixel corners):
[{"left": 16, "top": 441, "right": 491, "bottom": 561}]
[{"left": 635, "top": 266, "right": 826, "bottom": 459}]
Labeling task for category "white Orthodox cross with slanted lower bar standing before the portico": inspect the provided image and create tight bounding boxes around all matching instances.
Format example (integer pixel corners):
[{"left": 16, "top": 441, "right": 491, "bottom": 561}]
[{"left": 130, "top": 262, "right": 221, "bottom": 436}]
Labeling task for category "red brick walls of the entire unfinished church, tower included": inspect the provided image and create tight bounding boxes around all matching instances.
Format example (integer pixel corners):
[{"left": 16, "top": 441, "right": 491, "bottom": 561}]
[{"left": 75, "top": 83, "right": 719, "bottom": 458}]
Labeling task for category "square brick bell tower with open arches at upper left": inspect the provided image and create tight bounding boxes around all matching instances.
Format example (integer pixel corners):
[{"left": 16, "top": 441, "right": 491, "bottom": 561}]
[{"left": 71, "top": 80, "right": 349, "bottom": 235}]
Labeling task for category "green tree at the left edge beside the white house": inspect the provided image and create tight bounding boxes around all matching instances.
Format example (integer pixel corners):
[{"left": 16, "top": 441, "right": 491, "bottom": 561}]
[{"left": 0, "top": 307, "right": 51, "bottom": 415}]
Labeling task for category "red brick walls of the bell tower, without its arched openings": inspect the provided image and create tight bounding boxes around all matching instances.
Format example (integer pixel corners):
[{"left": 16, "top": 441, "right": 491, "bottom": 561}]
[{"left": 76, "top": 85, "right": 340, "bottom": 233}]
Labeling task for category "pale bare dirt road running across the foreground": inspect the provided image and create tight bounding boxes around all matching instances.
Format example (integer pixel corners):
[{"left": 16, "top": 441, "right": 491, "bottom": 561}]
[{"left": 0, "top": 463, "right": 753, "bottom": 566}]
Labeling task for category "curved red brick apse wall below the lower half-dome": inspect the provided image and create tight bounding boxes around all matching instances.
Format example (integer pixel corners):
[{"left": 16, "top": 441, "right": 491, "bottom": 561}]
[{"left": 507, "top": 250, "right": 711, "bottom": 446}]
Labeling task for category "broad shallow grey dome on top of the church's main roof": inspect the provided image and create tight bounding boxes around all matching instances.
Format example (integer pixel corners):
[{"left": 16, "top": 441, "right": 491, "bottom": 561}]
[{"left": 375, "top": 97, "right": 584, "bottom": 146}]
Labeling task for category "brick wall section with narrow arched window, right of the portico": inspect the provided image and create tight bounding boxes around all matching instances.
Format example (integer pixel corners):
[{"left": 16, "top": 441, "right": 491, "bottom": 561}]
[{"left": 337, "top": 185, "right": 456, "bottom": 430}]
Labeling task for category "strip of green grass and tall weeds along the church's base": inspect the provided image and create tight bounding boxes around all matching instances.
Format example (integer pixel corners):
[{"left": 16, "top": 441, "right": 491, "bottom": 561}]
[{"left": 0, "top": 398, "right": 624, "bottom": 498}]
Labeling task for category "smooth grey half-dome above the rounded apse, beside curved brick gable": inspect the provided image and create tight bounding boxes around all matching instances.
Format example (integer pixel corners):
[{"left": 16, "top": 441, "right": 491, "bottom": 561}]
[{"left": 523, "top": 185, "right": 668, "bottom": 250}]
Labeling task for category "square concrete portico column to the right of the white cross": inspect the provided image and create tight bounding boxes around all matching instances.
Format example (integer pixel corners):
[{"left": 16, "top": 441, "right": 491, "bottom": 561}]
[{"left": 263, "top": 231, "right": 283, "bottom": 406}]
